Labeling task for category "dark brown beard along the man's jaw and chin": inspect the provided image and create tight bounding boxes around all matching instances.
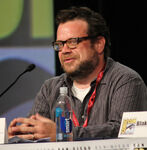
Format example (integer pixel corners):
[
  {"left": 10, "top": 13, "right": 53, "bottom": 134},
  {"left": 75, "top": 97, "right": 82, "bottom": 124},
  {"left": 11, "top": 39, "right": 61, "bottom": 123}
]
[{"left": 62, "top": 50, "right": 99, "bottom": 80}]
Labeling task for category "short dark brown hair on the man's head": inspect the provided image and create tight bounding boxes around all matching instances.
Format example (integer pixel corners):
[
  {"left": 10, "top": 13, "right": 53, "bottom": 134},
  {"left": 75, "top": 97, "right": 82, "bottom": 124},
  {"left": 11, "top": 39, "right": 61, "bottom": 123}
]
[{"left": 56, "top": 7, "right": 111, "bottom": 58}]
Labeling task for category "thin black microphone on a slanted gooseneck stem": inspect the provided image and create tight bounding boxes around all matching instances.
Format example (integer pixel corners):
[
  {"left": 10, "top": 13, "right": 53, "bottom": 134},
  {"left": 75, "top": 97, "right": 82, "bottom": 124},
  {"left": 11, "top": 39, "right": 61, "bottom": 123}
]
[{"left": 0, "top": 64, "right": 36, "bottom": 98}]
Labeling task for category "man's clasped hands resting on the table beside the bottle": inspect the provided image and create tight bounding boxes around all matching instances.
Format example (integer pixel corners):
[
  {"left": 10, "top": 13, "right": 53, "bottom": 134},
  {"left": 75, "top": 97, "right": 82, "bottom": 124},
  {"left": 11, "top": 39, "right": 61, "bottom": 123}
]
[{"left": 8, "top": 114, "right": 56, "bottom": 141}]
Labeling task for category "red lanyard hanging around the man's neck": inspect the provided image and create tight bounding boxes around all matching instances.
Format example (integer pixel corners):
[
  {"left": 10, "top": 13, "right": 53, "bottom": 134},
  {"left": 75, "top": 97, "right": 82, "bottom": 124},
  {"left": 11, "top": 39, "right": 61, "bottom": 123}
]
[{"left": 73, "top": 65, "right": 105, "bottom": 127}]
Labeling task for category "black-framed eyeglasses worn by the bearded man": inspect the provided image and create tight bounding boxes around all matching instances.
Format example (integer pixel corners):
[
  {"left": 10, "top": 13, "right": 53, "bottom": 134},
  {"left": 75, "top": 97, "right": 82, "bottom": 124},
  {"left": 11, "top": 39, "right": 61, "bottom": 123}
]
[{"left": 52, "top": 36, "right": 95, "bottom": 51}]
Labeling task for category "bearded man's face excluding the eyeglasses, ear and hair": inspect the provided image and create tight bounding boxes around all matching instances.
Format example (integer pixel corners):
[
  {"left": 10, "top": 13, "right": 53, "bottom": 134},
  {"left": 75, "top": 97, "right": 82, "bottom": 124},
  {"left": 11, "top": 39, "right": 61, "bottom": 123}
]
[{"left": 57, "top": 20, "right": 99, "bottom": 79}]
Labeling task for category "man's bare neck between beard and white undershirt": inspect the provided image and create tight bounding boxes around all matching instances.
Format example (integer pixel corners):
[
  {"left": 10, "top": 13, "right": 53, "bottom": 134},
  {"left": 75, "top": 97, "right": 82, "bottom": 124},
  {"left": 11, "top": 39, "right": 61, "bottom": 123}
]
[{"left": 73, "top": 62, "right": 105, "bottom": 89}]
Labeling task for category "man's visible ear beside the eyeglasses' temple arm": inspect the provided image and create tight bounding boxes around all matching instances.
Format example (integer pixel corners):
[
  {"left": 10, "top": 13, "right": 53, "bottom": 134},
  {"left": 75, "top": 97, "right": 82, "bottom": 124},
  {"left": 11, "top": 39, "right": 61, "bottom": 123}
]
[{"left": 95, "top": 36, "right": 106, "bottom": 55}]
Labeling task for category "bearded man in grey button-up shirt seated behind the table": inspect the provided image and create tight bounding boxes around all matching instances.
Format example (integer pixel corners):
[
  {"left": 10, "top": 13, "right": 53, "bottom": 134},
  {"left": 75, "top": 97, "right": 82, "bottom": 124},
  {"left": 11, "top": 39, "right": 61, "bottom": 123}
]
[{"left": 8, "top": 7, "right": 147, "bottom": 141}]
